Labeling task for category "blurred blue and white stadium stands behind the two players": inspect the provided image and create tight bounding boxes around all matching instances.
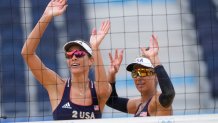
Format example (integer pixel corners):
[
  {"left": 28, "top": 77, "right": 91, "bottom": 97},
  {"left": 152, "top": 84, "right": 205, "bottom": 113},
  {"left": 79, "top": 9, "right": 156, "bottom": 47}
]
[{"left": 0, "top": 0, "right": 218, "bottom": 122}]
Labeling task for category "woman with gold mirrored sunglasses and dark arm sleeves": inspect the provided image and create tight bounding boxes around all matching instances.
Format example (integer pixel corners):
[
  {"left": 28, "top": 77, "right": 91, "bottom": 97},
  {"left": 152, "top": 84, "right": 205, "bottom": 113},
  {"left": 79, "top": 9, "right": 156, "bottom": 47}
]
[{"left": 107, "top": 35, "right": 175, "bottom": 117}]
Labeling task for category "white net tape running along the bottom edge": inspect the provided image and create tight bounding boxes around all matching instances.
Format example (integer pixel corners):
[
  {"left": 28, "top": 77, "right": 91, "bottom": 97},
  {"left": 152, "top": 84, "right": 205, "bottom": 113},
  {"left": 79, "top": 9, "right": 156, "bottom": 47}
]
[{"left": 17, "top": 114, "right": 218, "bottom": 123}]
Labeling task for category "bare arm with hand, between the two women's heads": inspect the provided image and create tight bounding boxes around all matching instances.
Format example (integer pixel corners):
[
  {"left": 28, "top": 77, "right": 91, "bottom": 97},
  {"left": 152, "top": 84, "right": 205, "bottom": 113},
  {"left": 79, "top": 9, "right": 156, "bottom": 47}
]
[{"left": 90, "top": 21, "right": 111, "bottom": 111}]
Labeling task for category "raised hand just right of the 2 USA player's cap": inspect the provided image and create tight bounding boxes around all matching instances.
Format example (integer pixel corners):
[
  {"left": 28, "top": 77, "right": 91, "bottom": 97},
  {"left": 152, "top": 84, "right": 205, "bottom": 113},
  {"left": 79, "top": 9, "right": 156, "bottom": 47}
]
[{"left": 90, "top": 20, "right": 110, "bottom": 50}]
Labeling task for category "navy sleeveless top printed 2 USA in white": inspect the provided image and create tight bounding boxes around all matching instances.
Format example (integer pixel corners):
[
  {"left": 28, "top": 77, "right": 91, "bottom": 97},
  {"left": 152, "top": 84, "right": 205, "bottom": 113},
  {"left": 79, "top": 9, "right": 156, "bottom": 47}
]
[{"left": 53, "top": 79, "right": 102, "bottom": 120}]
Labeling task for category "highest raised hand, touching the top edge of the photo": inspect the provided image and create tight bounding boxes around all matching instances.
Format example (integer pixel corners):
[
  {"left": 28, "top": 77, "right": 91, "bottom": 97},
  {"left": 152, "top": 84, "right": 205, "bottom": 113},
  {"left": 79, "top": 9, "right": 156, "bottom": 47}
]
[{"left": 44, "top": 0, "right": 67, "bottom": 16}]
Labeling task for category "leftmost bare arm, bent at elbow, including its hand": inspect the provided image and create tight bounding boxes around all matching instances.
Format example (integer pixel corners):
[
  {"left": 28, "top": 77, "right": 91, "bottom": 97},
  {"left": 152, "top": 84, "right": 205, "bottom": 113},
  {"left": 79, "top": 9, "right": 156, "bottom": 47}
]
[{"left": 21, "top": 0, "right": 67, "bottom": 88}]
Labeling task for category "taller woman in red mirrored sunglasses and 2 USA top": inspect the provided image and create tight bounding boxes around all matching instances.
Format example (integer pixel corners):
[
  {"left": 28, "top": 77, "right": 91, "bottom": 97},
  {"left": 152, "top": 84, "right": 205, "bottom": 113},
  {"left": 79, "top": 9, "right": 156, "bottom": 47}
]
[{"left": 22, "top": 0, "right": 111, "bottom": 120}]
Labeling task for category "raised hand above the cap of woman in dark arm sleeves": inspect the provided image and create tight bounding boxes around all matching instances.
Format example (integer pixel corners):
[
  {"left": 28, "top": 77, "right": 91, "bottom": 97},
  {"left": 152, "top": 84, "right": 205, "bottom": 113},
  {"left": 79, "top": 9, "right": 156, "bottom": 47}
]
[{"left": 141, "top": 34, "right": 159, "bottom": 64}]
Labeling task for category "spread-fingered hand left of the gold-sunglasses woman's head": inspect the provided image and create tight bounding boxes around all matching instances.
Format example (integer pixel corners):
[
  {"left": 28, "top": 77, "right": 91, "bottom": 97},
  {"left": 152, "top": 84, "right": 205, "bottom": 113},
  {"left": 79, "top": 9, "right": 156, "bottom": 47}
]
[{"left": 108, "top": 49, "right": 123, "bottom": 80}]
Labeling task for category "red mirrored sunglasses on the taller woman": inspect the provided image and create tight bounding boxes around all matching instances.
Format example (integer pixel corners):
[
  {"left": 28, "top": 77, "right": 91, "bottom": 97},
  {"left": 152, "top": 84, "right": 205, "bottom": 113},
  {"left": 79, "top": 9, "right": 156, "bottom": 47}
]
[{"left": 65, "top": 50, "right": 86, "bottom": 59}]
